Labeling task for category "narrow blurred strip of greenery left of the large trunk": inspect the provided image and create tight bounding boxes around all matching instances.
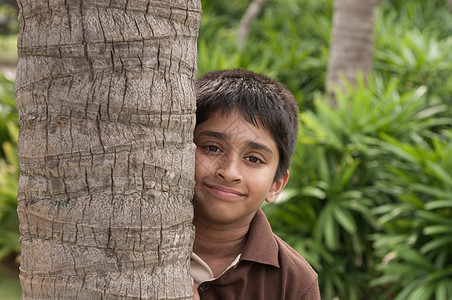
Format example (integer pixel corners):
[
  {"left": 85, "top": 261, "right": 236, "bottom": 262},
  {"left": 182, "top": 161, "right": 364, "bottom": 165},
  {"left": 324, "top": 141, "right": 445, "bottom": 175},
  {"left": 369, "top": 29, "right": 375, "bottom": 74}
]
[{"left": 0, "top": 0, "right": 21, "bottom": 300}]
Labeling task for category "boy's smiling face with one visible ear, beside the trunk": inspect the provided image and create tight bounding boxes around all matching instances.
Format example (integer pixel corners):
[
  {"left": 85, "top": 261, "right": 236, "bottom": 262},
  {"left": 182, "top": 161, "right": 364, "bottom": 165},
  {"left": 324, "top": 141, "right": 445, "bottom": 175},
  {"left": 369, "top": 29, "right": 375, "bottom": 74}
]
[{"left": 194, "top": 111, "right": 289, "bottom": 225}]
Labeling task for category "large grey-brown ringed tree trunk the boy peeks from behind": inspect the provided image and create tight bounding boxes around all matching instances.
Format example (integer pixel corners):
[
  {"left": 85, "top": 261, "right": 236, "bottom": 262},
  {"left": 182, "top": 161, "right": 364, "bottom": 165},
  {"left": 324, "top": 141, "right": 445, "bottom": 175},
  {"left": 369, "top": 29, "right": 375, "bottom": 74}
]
[{"left": 16, "top": 0, "right": 201, "bottom": 299}]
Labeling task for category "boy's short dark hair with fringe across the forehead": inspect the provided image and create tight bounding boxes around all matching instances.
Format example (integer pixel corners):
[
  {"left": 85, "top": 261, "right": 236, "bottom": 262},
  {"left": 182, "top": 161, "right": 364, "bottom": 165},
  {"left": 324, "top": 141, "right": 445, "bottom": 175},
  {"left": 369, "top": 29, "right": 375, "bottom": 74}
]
[{"left": 196, "top": 69, "right": 298, "bottom": 180}]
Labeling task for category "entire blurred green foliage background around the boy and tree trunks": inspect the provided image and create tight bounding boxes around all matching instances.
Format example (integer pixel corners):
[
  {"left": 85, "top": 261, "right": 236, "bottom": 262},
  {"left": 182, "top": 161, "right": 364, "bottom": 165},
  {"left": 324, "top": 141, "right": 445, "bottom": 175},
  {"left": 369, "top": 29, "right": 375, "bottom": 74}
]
[{"left": 0, "top": 0, "right": 452, "bottom": 300}]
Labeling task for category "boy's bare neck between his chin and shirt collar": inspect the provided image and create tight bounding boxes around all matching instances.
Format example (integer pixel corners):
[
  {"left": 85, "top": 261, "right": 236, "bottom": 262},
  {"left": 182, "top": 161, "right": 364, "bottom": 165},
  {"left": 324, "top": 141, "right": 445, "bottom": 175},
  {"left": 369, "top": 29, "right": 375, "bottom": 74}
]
[{"left": 193, "top": 218, "right": 250, "bottom": 277}]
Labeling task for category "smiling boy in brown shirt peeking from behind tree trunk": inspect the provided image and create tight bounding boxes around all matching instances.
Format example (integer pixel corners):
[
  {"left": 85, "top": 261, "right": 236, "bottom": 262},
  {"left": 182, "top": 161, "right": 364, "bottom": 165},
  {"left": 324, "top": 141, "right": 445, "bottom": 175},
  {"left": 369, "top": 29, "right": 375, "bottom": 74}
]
[{"left": 190, "top": 70, "right": 320, "bottom": 300}]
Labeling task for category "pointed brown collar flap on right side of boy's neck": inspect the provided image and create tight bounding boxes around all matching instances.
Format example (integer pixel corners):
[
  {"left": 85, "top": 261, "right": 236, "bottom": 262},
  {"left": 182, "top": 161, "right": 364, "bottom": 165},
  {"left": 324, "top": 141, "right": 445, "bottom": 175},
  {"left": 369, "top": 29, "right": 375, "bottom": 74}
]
[{"left": 240, "top": 209, "right": 279, "bottom": 268}]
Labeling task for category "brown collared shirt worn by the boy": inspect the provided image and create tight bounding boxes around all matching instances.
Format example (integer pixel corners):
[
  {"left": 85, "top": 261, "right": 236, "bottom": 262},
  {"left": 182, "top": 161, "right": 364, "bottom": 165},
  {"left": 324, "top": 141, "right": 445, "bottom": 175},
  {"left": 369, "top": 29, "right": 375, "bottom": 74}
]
[{"left": 191, "top": 209, "right": 320, "bottom": 300}]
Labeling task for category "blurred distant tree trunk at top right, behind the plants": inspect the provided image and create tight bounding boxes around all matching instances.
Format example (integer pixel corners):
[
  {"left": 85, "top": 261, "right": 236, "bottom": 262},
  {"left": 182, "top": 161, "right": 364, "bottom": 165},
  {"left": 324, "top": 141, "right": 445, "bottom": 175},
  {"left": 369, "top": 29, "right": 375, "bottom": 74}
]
[{"left": 326, "top": 0, "right": 380, "bottom": 91}]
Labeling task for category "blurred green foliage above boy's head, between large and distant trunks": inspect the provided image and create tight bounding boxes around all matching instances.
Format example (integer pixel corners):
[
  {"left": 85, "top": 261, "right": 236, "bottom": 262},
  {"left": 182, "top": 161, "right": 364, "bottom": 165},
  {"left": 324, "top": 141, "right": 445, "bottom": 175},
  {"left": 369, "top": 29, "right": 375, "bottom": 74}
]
[{"left": 198, "top": 0, "right": 332, "bottom": 107}]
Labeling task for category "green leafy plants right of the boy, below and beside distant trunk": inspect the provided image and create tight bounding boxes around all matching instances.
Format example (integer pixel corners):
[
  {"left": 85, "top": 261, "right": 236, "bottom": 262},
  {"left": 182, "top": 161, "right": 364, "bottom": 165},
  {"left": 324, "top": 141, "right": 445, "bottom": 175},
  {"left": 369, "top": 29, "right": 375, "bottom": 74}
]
[{"left": 264, "top": 0, "right": 452, "bottom": 299}]
